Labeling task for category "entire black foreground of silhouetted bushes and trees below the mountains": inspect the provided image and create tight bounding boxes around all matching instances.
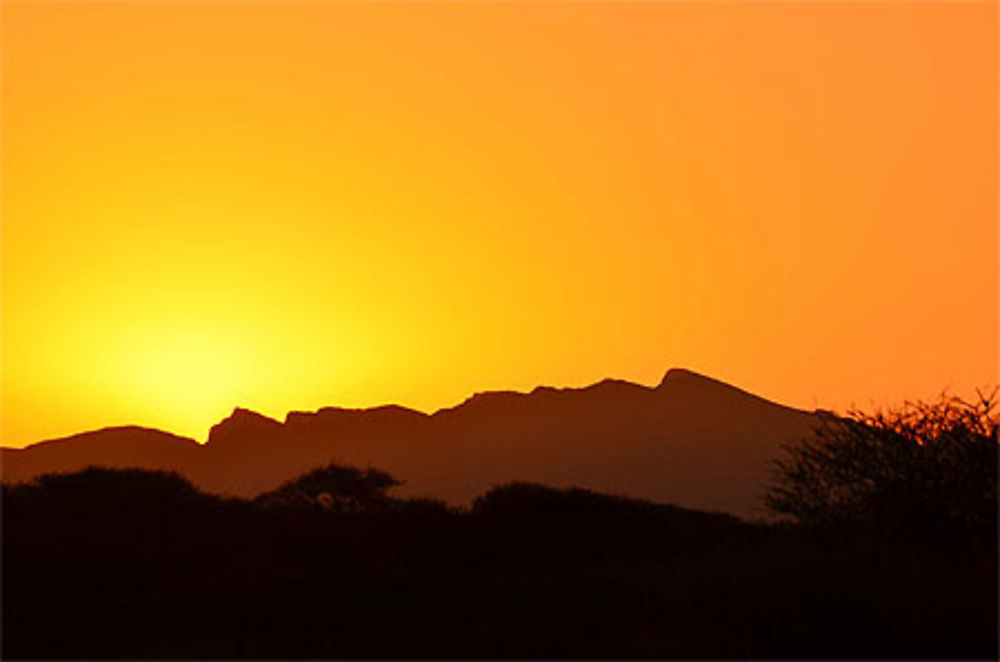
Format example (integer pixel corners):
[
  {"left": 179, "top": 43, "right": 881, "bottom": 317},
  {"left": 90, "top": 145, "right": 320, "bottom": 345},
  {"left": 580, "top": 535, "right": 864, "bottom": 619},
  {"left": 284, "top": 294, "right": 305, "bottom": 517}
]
[{"left": 3, "top": 399, "right": 997, "bottom": 659}]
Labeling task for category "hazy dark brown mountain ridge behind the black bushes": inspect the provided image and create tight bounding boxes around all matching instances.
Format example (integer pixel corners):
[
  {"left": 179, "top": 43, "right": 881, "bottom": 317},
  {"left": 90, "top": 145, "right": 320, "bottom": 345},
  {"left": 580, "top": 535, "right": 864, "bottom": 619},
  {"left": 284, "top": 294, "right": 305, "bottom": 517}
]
[{"left": 2, "top": 368, "right": 820, "bottom": 517}]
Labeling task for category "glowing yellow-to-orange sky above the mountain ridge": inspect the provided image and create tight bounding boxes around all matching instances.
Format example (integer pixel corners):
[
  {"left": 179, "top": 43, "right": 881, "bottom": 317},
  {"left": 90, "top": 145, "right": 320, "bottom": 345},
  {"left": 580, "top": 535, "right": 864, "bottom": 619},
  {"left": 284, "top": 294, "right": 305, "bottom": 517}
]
[{"left": 2, "top": 0, "right": 998, "bottom": 446}]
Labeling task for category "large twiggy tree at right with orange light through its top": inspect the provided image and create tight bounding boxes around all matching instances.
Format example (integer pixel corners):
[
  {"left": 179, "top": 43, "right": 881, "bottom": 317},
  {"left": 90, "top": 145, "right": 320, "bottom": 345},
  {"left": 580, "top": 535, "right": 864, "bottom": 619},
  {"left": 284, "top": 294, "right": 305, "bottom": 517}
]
[{"left": 764, "top": 390, "right": 998, "bottom": 534}]
